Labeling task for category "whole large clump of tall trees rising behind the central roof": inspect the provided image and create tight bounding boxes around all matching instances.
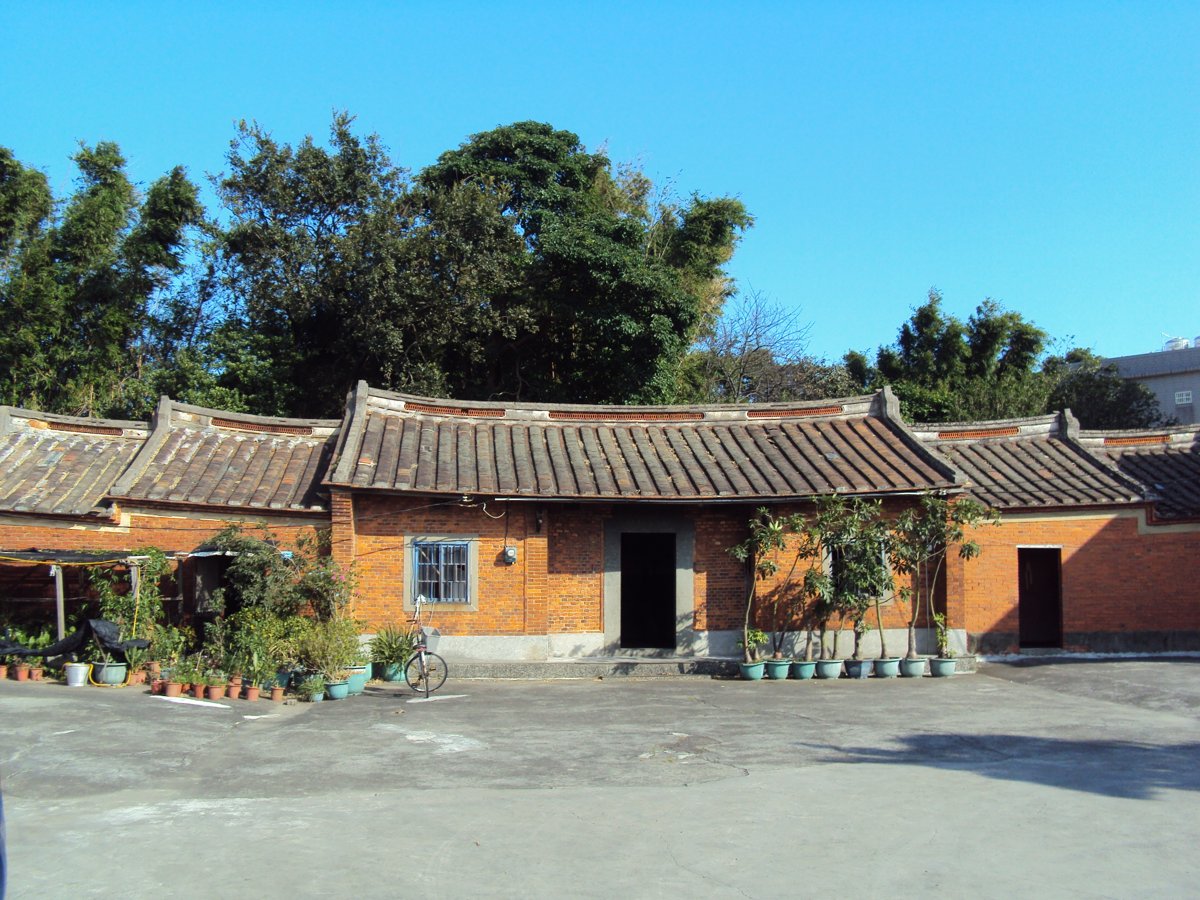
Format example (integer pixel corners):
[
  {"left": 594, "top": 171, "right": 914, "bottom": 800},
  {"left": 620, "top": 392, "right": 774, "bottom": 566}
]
[{"left": 211, "top": 114, "right": 750, "bottom": 415}]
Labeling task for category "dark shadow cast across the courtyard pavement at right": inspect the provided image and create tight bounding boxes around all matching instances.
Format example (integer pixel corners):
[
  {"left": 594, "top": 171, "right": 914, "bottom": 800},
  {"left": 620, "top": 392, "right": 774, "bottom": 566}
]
[{"left": 802, "top": 734, "right": 1200, "bottom": 800}]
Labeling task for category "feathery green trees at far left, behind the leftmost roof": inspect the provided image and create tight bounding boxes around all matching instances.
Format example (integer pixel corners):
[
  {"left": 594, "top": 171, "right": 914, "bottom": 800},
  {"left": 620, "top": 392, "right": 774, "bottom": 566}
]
[{"left": 0, "top": 142, "right": 203, "bottom": 415}]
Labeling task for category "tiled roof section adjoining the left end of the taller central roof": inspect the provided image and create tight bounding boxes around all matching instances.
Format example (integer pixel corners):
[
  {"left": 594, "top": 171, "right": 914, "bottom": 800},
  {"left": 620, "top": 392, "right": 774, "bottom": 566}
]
[{"left": 113, "top": 397, "right": 340, "bottom": 511}]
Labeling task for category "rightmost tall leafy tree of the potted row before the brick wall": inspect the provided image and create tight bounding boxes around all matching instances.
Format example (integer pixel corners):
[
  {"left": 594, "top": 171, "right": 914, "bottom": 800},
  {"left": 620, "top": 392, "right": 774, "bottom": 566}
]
[{"left": 889, "top": 492, "right": 1000, "bottom": 677}]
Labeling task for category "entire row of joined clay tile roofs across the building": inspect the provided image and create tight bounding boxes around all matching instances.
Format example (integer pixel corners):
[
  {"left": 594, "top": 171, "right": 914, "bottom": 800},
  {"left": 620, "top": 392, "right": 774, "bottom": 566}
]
[{"left": 0, "top": 383, "right": 1200, "bottom": 518}]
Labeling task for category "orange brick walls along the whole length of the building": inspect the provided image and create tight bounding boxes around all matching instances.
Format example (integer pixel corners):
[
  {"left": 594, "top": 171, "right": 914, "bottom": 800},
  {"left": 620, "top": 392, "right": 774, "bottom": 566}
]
[{"left": 0, "top": 490, "right": 1200, "bottom": 652}]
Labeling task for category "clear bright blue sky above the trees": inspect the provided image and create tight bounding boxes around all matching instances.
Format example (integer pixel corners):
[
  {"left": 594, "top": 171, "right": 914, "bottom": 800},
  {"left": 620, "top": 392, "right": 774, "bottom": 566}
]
[{"left": 0, "top": 0, "right": 1200, "bottom": 359}]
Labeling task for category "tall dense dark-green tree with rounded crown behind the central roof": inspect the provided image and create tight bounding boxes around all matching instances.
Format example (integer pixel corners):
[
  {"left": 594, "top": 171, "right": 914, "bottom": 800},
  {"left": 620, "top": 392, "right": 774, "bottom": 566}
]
[{"left": 419, "top": 122, "right": 751, "bottom": 403}]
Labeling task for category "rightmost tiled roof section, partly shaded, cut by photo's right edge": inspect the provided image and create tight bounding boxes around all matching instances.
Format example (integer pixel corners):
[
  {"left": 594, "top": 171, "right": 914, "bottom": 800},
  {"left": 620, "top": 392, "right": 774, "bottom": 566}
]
[{"left": 1080, "top": 425, "right": 1200, "bottom": 518}]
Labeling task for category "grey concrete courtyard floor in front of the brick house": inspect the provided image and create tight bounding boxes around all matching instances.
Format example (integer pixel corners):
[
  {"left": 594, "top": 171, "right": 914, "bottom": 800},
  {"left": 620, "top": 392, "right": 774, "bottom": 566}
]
[{"left": 0, "top": 659, "right": 1200, "bottom": 899}]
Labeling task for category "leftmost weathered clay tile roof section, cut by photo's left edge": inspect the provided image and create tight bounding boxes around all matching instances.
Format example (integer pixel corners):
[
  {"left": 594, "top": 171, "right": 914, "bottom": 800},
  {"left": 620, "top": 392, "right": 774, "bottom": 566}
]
[{"left": 0, "top": 407, "right": 149, "bottom": 516}]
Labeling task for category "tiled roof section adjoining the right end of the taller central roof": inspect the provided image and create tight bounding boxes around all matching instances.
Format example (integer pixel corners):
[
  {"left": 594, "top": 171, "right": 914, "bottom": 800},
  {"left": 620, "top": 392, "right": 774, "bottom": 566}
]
[{"left": 912, "top": 414, "right": 1141, "bottom": 510}]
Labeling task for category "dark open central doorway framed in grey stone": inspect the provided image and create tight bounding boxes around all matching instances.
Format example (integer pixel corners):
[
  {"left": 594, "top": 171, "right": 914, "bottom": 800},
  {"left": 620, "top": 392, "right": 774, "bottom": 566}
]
[{"left": 620, "top": 532, "right": 676, "bottom": 650}]
